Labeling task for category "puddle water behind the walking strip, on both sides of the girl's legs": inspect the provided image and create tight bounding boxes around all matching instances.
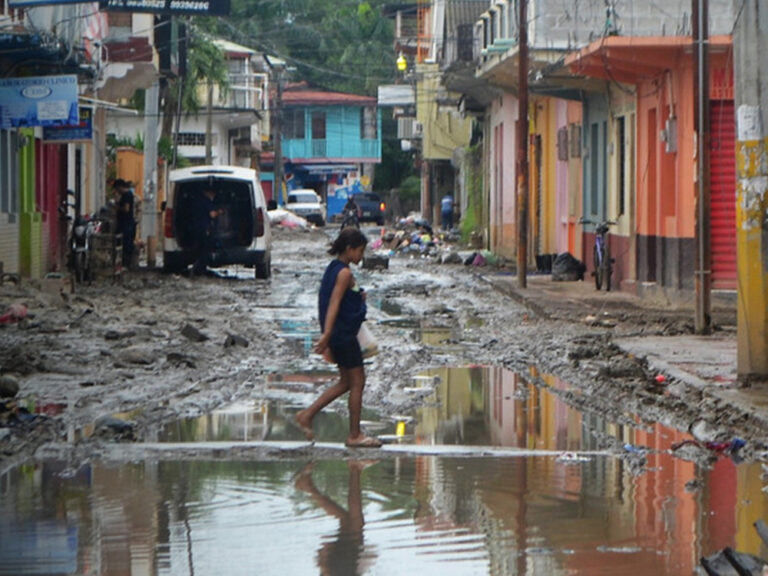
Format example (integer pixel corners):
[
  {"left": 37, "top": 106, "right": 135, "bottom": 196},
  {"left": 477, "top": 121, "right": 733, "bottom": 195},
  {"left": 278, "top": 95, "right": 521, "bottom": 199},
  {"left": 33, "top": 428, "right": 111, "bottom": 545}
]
[{"left": 156, "top": 366, "right": 691, "bottom": 452}]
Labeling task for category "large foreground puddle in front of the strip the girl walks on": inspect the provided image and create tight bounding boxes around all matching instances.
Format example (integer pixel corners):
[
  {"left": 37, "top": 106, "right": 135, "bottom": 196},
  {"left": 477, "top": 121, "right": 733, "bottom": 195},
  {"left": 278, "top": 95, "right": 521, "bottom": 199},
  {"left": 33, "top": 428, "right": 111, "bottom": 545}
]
[{"left": 0, "top": 455, "right": 768, "bottom": 576}]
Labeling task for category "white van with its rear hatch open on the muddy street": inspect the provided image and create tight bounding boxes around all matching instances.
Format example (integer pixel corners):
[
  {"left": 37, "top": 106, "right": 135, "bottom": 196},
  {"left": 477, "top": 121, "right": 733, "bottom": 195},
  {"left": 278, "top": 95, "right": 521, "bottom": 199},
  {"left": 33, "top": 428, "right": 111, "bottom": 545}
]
[{"left": 163, "top": 166, "right": 272, "bottom": 278}]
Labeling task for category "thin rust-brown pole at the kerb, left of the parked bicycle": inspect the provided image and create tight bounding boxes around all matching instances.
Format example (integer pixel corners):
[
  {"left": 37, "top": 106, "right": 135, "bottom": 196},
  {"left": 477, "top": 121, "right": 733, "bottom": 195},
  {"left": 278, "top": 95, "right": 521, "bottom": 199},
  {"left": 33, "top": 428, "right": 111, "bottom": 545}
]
[{"left": 517, "top": 0, "right": 528, "bottom": 288}]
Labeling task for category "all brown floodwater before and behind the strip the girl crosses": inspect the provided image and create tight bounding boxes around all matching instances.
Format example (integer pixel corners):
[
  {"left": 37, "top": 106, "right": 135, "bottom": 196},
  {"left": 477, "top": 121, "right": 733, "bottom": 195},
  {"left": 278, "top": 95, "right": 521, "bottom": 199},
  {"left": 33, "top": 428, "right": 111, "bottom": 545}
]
[{"left": 0, "top": 367, "right": 768, "bottom": 576}]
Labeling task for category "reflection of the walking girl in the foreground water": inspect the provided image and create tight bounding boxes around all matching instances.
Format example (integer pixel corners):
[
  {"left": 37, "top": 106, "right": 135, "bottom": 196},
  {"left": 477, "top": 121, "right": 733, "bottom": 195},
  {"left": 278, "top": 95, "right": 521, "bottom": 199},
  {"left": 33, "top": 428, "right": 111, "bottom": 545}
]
[{"left": 295, "top": 460, "right": 375, "bottom": 576}]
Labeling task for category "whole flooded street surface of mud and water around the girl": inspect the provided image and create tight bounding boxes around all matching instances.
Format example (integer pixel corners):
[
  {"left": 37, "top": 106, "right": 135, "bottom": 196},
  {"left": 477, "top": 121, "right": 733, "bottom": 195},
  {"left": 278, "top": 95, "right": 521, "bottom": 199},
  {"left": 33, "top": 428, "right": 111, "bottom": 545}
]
[{"left": 0, "top": 230, "right": 768, "bottom": 576}]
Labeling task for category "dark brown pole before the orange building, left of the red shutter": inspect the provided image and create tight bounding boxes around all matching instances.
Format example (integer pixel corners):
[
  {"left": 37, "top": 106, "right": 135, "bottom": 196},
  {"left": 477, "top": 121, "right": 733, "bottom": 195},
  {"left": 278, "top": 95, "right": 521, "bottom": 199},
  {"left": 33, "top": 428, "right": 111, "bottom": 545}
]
[{"left": 692, "top": 0, "right": 712, "bottom": 334}]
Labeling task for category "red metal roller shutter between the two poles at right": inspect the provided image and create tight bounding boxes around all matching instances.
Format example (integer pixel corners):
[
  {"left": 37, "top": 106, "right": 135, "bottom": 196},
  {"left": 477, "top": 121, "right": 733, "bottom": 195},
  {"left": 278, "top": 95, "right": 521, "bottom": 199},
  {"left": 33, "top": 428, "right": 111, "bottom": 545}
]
[{"left": 710, "top": 100, "right": 738, "bottom": 290}]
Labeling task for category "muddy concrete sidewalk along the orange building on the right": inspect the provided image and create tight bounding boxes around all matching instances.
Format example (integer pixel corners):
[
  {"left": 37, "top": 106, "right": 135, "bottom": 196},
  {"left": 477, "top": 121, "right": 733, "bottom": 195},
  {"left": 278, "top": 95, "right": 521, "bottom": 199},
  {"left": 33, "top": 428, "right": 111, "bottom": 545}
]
[{"left": 483, "top": 271, "right": 768, "bottom": 422}]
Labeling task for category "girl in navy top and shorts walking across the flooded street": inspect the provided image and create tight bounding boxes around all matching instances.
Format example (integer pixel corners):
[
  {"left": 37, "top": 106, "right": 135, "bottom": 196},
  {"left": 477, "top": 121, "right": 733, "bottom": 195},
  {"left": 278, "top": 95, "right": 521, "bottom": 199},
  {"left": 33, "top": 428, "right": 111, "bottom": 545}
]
[{"left": 295, "top": 228, "right": 381, "bottom": 448}]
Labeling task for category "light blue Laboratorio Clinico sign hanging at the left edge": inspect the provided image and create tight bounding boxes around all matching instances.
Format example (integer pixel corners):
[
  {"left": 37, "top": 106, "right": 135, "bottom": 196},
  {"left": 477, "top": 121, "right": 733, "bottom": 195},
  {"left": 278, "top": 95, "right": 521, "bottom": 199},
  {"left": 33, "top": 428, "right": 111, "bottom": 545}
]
[{"left": 0, "top": 74, "right": 79, "bottom": 128}]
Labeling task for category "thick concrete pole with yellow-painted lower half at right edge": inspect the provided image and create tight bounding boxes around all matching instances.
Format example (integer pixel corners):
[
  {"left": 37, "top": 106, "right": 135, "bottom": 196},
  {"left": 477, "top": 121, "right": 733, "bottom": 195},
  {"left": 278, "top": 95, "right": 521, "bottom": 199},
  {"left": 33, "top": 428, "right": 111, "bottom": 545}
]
[{"left": 732, "top": 0, "right": 768, "bottom": 378}]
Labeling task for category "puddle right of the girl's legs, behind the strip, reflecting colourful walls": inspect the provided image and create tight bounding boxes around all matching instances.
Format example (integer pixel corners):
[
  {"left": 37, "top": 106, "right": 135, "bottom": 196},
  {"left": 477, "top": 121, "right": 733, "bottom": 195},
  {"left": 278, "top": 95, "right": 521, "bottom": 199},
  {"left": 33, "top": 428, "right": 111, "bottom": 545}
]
[{"left": 387, "top": 366, "right": 690, "bottom": 451}]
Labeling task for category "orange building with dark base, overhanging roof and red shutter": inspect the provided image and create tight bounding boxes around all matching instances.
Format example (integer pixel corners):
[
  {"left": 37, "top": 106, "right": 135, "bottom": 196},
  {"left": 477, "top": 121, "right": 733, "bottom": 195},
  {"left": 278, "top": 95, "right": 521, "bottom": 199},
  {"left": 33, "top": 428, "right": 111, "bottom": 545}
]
[{"left": 566, "top": 36, "right": 736, "bottom": 299}]
